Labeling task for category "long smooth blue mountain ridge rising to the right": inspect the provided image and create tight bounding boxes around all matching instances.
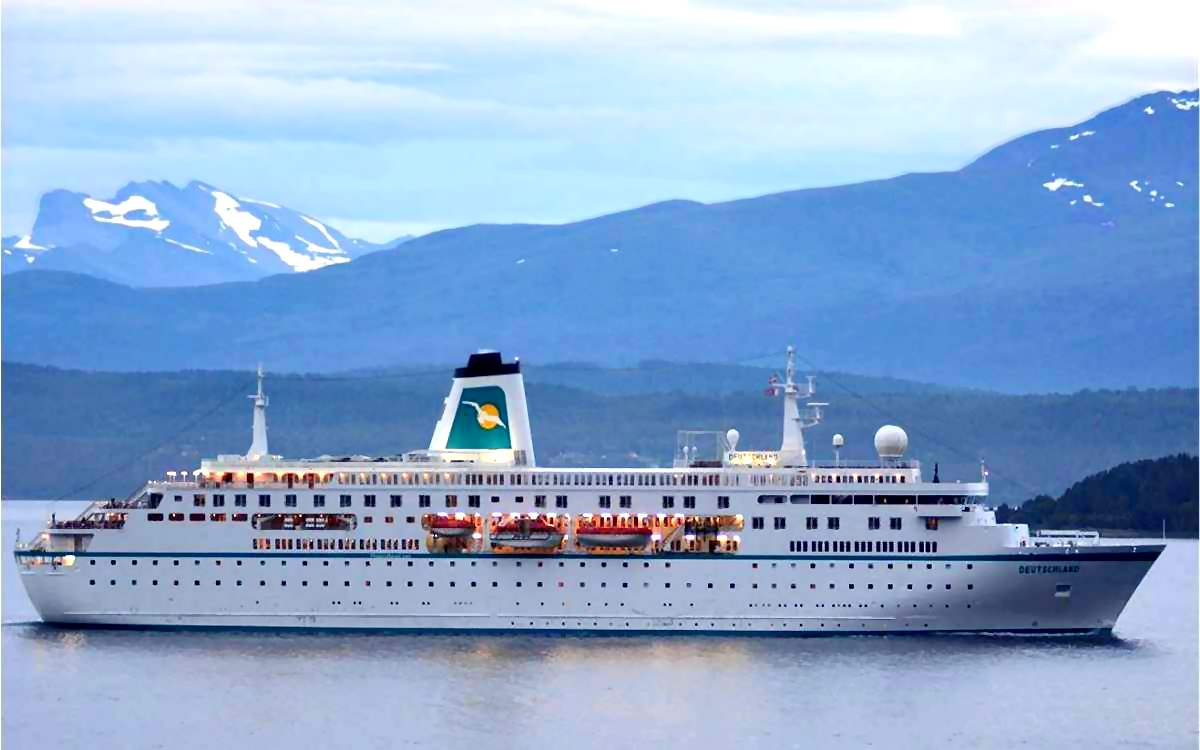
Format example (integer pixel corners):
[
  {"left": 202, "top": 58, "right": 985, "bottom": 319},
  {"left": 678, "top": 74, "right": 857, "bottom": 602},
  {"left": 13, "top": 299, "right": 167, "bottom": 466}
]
[{"left": 4, "top": 91, "right": 1200, "bottom": 391}]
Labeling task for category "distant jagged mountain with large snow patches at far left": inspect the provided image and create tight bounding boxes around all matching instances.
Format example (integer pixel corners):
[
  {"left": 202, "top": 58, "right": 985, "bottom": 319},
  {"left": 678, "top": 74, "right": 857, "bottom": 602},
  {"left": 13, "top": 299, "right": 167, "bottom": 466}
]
[{"left": 0, "top": 181, "right": 403, "bottom": 287}]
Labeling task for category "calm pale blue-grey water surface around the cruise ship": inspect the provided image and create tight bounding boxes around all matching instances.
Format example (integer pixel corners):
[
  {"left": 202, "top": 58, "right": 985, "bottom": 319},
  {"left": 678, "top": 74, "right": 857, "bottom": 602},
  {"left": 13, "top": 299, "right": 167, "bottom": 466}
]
[{"left": 2, "top": 502, "right": 1198, "bottom": 750}]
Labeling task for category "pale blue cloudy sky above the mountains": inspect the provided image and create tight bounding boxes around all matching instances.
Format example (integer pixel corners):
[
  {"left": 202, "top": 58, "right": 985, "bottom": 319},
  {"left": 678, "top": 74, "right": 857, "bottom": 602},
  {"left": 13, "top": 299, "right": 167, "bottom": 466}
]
[{"left": 0, "top": 0, "right": 1200, "bottom": 241}]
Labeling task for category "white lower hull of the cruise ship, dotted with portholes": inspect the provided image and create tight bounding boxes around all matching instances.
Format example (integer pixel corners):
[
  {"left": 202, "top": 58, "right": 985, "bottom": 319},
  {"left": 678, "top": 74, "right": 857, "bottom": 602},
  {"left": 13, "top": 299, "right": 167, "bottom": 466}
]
[{"left": 23, "top": 545, "right": 1162, "bottom": 635}]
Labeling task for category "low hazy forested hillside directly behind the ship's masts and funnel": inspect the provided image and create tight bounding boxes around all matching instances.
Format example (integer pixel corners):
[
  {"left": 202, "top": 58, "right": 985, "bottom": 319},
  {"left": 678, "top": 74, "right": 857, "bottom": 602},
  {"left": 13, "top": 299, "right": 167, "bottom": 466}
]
[{"left": 2, "top": 364, "right": 1196, "bottom": 503}]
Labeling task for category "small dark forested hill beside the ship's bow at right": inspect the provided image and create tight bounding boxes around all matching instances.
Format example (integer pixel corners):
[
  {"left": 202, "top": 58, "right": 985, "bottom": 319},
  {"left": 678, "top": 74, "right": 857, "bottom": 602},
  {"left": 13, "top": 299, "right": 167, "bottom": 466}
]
[{"left": 996, "top": 454, "right": 1200, "bottom": 536}]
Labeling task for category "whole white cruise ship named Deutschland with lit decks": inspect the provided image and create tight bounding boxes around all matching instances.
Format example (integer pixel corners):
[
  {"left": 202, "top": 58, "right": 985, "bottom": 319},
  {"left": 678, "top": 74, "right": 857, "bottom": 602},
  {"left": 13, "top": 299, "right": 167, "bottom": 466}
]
[{"left": 14, "top": 348, "right": 1163, "bottom": 635}]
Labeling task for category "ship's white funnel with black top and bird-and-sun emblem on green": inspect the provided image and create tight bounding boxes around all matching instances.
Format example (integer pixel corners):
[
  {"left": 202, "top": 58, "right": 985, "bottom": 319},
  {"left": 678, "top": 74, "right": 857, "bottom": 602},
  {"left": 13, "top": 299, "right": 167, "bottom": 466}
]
[{"left": 430, "top": 352, "right": 535, "bottom": 466}]
